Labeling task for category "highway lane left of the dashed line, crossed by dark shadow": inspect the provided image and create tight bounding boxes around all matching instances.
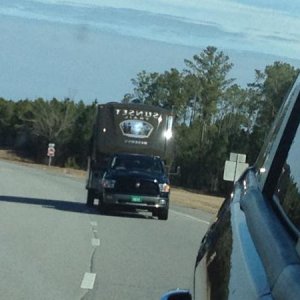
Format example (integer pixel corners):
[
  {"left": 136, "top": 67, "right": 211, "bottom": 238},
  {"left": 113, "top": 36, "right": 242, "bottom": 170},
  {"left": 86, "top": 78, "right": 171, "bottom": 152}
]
[{"left": 0, "top": 162, "right": 92, "bottom": 299}]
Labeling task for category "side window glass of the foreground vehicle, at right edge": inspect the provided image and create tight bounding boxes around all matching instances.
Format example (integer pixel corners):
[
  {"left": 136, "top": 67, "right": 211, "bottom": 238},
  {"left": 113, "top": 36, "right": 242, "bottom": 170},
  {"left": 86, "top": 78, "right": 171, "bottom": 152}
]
[{"left": 276, "top": 122, "right": 300, "bottom": 232}]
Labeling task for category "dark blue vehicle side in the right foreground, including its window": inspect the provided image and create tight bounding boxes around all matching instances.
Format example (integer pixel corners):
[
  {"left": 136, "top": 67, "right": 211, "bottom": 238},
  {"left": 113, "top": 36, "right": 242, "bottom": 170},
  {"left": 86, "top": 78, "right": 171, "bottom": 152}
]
[{"left": 162, "top": 76, "right": 300, "bottom": 300}]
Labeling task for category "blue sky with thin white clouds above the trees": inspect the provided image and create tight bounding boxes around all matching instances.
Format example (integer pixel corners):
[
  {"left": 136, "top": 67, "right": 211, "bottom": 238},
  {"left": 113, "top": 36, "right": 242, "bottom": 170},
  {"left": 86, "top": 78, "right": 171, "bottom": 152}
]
[{"left": 0, "top": 0, "right": 300, "bottom": 102}]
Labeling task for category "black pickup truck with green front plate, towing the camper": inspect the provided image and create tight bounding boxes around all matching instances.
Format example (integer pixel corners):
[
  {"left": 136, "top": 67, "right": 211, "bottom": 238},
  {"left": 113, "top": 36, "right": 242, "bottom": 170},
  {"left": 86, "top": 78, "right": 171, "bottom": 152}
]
[{"left": 101, "top": 153, "right": 170, "bottom": 220}]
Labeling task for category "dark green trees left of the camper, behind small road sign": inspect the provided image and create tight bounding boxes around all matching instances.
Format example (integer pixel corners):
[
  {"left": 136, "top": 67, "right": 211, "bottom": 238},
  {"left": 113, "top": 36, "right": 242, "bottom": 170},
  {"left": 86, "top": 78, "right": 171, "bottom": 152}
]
[{"left": 0, "top": 98, "right": 96, "bottom": 168}]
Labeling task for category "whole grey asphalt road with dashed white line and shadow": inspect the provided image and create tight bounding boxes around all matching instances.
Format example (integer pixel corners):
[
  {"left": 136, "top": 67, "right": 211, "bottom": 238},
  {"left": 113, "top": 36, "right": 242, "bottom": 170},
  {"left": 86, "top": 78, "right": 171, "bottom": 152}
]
[{"left": 0, "top": 161, "right": 211, "bottom": 300}]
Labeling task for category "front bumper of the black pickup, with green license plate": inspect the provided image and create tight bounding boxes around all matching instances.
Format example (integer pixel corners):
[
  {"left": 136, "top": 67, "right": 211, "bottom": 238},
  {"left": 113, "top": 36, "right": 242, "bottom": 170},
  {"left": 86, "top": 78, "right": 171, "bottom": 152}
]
[{"left": 103, "top": 193, "right": 169, "bottom": 210}]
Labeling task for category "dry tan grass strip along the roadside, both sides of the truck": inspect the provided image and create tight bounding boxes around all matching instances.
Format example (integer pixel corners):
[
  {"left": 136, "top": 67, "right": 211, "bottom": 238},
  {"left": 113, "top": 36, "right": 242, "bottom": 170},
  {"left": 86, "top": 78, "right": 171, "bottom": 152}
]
[{"left": 0, "top": 150, "right": 224, "bottom": 214}]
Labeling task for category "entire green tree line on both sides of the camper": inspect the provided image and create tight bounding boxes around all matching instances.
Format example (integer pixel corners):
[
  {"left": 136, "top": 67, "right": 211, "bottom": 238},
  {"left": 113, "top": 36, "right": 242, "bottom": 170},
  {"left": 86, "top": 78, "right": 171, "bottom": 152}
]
[{"left": 0, "top": 46, "right": 299, "bottom": 193}]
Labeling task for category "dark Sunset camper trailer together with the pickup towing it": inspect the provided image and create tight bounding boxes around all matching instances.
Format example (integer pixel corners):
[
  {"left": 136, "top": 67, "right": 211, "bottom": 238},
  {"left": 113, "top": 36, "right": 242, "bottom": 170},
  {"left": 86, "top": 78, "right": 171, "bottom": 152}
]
[{"left": 86, "top": 102, "right": 173, "bottom": 219}]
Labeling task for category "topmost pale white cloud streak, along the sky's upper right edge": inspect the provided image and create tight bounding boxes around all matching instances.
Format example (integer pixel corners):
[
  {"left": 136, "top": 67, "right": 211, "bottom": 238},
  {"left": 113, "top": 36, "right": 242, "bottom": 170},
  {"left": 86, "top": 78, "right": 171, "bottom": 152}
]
[{"left": 32, "top": 0, "right": 300, "bottom": 35}]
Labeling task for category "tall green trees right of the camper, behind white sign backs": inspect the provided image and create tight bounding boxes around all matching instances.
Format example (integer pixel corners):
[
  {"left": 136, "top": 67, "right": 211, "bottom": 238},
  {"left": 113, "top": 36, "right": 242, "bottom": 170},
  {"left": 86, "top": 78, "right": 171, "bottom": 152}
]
[{"left": 124, "top": 46, "right": 298, "bottom": 192}]
